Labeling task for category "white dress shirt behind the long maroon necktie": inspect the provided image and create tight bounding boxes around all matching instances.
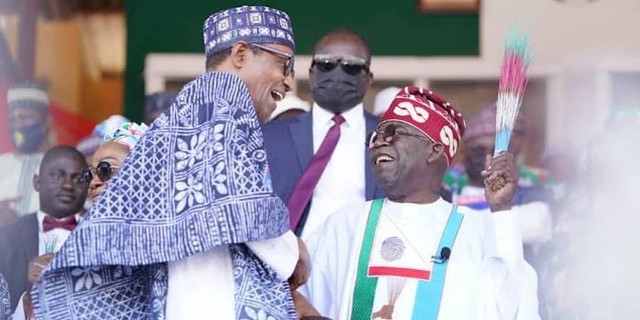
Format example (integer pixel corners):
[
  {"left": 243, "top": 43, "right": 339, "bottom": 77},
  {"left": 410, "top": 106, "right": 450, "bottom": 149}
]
[{"left": 302, "top": 104, "right": 367, "bottom": 239}]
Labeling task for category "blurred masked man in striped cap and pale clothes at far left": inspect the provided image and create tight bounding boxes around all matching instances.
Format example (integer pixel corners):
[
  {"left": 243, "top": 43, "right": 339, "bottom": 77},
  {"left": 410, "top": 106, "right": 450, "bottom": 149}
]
[{"left": 0, "top": 82, "right": 51, "bottom": 225}]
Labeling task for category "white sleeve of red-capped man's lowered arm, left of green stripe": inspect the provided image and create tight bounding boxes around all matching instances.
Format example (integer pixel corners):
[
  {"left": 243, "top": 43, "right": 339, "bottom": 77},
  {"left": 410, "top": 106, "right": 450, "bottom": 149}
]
[{"left": 298, "top": 202, "right": 371, "bottom": 319}]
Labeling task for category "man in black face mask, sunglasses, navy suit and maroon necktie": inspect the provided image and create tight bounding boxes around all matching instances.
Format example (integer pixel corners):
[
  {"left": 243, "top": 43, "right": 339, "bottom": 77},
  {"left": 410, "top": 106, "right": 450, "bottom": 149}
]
[{"left": 264, "top": 29, "right": 383, "bottom": 239}]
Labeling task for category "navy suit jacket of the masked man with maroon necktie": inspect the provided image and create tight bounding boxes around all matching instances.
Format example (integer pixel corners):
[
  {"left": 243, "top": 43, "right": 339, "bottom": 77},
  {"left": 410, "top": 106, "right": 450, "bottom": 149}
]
[{"left": 263, "top": 112, "right": 384, "bottom": 235}]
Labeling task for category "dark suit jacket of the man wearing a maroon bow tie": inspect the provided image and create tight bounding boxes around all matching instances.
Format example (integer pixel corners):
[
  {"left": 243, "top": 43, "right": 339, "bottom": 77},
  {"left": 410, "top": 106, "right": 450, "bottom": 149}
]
[{"left": 0, "top": 213, "right": 38, "bottom": 310}]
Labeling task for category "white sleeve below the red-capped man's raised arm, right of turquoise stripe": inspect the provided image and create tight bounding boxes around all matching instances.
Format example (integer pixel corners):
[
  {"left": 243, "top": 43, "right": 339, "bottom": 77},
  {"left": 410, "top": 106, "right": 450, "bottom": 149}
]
[{"left": 482, "top": 210, "right": 540, "bottom": 320}]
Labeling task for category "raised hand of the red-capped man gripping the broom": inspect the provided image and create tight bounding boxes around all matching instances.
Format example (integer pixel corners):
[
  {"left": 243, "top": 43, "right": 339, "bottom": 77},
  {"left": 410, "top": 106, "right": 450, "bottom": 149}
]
[{"left": 482, "top": 152, "right": 519, "bottom": 212}]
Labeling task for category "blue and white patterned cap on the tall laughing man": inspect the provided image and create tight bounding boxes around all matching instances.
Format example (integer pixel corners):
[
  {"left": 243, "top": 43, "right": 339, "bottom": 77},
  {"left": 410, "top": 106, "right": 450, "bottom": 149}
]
[{"left": 203, "top": 6, "right": 295, "bottom": 57}]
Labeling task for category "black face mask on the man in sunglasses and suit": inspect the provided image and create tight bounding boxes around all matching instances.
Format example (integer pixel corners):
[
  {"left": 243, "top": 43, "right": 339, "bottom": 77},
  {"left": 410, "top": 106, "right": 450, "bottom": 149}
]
[{"left": 311, "top": 67, "right": 367, "bottom": 114}]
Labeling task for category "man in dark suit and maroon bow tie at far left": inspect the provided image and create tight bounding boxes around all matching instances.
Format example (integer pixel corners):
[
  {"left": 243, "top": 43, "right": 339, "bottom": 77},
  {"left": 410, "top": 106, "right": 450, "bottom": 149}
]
[{"left": 0, "top": 146, "right": 88, "bottom": 313}]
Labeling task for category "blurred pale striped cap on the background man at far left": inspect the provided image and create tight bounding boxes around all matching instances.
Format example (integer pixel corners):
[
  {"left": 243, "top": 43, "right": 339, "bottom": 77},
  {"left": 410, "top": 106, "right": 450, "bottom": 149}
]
[{"left": 7, "top": 81, "right": 49, "bottom": 112}]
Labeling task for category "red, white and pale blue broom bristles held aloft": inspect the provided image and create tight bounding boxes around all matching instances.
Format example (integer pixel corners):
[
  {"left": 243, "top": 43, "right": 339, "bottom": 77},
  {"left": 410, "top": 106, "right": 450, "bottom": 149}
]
[{"left": 495, "top": 30, "right": 532, "bottom": 155}]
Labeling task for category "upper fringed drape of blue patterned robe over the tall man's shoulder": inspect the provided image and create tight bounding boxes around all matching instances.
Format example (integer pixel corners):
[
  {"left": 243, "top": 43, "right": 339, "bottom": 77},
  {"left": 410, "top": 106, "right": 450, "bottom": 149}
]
[{"left": 50, "top": 72, "right": 289, "bottom": 270}]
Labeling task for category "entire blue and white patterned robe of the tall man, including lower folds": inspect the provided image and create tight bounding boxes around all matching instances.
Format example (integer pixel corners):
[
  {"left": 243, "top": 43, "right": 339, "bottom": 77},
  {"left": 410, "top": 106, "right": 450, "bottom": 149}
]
[{"left": 32, "top": 72, "right": 295, "bottom": 320}]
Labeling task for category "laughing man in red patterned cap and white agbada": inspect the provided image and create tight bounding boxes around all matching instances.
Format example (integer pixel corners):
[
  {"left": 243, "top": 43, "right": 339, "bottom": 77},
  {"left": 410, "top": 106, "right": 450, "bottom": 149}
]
[{"left": 300, "top": 87, "right": 539, "bottom": 320}]
